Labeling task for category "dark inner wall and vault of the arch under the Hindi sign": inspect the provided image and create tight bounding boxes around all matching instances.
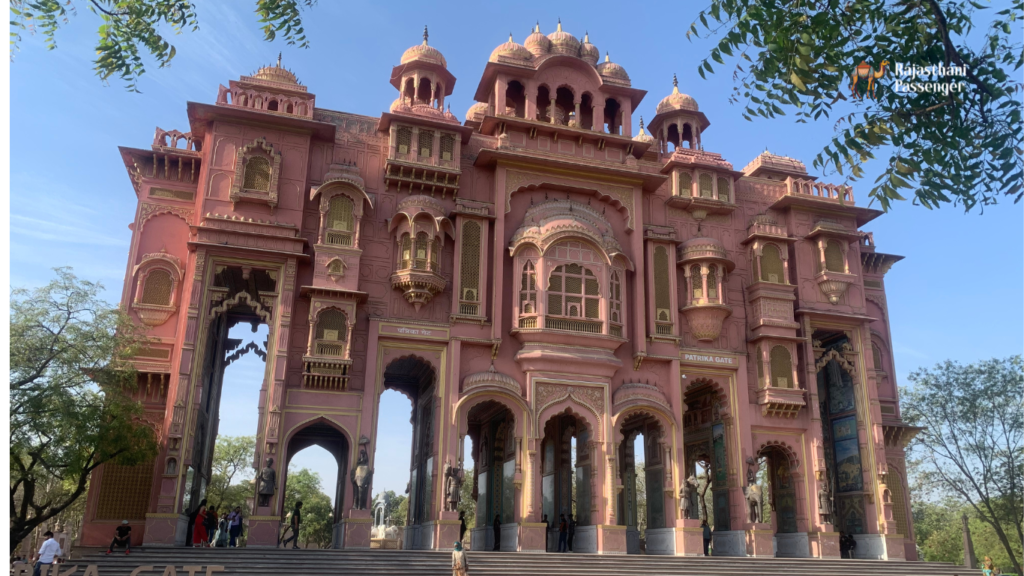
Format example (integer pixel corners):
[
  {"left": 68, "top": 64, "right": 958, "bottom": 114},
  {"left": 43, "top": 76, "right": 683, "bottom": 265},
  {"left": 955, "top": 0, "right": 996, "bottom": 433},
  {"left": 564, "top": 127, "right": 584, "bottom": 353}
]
[{"left": 374, "top": 356, "right": 438, "bottom": 549}]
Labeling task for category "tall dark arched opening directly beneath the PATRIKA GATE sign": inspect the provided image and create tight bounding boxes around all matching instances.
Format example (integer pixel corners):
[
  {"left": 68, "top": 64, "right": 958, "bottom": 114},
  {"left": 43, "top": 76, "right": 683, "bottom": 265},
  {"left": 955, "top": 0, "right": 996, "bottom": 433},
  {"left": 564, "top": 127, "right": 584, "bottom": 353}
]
[{"left": 683, "top": 378, "right": 731, "bottom": 532}]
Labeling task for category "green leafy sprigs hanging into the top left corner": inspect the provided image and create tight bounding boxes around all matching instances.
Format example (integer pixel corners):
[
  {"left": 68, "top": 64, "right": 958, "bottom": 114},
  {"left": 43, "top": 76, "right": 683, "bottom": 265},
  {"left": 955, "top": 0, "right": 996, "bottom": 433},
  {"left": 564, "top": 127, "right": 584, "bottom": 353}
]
[{"left": 10, "top": 0, "right": 316, "bottom": 92}]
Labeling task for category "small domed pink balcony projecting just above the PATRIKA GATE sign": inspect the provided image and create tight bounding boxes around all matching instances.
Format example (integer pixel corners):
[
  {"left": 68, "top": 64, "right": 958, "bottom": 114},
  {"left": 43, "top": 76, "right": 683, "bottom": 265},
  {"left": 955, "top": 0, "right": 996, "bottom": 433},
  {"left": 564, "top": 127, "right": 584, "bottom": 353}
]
[{"left": 677, "top": 238, "right": 736, "bottom": 342}]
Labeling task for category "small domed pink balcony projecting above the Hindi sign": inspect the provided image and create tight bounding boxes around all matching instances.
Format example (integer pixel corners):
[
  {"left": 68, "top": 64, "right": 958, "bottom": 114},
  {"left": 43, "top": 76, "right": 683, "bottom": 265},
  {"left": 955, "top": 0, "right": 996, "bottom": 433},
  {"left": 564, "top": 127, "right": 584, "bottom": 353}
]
[{"left": 388, "top": 195, "right": 455, "bottom": 311}]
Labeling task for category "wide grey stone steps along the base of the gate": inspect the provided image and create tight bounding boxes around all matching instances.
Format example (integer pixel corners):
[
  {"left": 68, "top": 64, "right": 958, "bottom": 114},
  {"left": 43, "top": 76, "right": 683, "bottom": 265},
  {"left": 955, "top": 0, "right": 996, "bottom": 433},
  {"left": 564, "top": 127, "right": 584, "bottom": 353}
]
[{"left": 74, "top": 548, "right": 979, "bottom": 576}]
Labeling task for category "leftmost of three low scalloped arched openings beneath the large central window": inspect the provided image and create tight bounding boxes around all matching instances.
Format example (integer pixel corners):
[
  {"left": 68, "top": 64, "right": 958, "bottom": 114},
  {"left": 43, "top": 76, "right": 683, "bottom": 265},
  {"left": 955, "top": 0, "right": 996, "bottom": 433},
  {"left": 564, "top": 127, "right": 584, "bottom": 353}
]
[{"left": 467, "top": 400, "right": 518, "bottom": 551}]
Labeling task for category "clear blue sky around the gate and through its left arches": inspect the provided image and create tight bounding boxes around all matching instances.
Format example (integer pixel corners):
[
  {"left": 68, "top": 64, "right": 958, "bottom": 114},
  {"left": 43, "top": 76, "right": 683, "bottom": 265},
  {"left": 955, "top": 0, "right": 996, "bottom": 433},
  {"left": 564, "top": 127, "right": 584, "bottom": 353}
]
[{"left": 10, "top": 0, "right": 1024, "bottom": 493}]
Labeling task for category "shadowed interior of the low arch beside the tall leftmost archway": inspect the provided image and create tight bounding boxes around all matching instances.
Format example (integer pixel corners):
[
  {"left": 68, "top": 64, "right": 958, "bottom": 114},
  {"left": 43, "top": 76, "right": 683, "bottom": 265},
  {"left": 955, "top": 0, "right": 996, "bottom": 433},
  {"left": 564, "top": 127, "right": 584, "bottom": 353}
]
[{"left": 283, "top": 419, "right": 350, "bottom": 548}]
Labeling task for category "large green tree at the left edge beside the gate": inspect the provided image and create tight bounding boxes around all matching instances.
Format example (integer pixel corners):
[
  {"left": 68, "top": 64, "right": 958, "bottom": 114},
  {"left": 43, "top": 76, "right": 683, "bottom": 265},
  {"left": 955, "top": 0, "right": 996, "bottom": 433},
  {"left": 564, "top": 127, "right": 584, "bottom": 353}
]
[{"left": 10, "top": 269, "right": 157, "bottom": 551}]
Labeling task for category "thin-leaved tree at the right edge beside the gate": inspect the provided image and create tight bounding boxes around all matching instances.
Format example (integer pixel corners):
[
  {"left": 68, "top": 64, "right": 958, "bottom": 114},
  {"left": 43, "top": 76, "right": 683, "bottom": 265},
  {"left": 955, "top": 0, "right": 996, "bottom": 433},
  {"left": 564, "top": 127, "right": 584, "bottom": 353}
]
[{"left": 900, "top": 356, "right": 1024, "bottom": 574}]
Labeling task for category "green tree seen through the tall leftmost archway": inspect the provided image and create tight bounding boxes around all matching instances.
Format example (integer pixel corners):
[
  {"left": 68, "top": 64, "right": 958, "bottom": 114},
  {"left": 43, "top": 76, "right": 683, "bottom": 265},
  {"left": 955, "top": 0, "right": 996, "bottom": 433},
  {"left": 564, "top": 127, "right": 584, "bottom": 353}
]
[{"left": 206, "top": 436, "right": 256, "bottom": 512}]
